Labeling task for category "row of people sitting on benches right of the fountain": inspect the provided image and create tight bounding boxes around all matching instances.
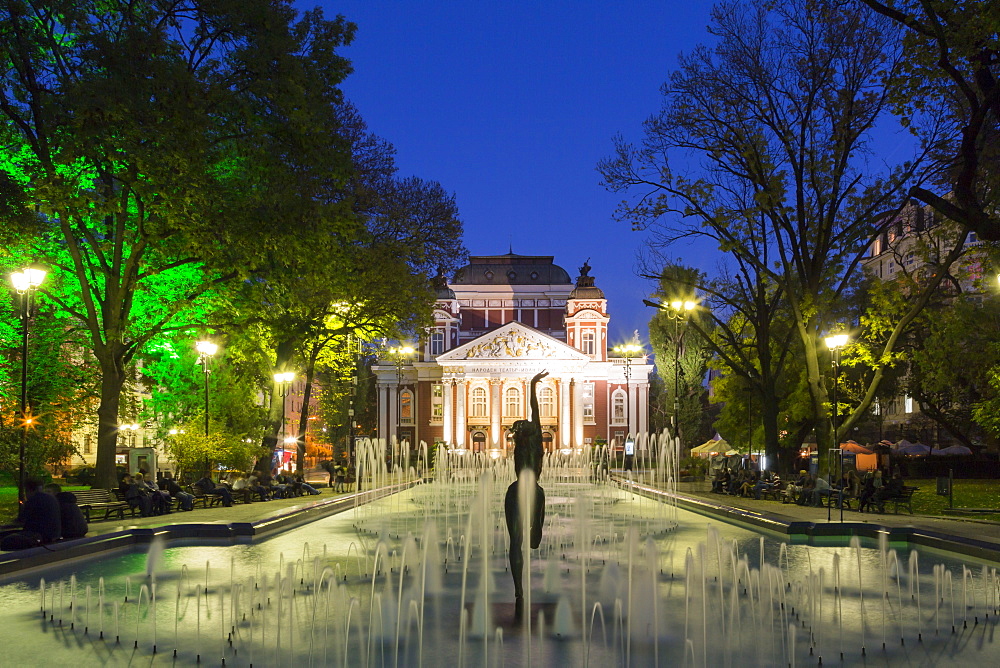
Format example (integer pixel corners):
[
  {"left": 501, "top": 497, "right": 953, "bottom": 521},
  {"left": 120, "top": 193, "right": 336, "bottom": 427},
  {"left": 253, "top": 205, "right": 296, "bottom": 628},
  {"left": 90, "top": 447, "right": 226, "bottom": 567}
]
[{"left": 712, "top": 469, "right": 904, "bottom": 513}]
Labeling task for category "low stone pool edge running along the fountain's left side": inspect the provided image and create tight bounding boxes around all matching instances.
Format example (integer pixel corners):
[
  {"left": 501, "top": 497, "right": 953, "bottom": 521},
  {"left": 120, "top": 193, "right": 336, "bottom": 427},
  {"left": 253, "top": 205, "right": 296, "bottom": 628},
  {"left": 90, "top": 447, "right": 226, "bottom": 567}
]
[{"left": 0, "top": 480, "right": 420, "bottom": 583}]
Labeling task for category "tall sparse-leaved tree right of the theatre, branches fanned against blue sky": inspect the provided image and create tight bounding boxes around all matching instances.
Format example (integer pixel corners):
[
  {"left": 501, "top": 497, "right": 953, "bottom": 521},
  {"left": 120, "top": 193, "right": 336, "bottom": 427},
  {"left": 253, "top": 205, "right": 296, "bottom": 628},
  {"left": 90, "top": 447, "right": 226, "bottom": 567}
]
[{"left": 600, "top": 0, "right": 961, "bottom": 464}]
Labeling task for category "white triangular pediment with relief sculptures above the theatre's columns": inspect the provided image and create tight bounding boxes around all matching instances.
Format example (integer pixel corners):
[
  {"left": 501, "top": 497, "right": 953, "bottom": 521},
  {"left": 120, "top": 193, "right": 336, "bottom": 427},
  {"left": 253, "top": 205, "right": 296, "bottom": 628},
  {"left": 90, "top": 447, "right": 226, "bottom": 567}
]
[{"left": 437, "top": 322, "right": 590, "bottom": 364}]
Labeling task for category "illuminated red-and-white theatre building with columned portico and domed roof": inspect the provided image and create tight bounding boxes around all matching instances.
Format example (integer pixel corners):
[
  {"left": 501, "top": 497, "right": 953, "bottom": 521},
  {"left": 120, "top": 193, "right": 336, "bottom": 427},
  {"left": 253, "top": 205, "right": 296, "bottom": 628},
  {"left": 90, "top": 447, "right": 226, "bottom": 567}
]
[{"left": 374, "top": 253, "right": 652, "bottom": 451}]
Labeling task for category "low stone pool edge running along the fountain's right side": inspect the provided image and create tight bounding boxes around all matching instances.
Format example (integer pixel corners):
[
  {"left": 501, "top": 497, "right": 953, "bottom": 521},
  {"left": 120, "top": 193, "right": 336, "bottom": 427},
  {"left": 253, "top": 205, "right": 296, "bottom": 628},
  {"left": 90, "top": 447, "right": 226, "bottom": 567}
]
[{"left": 614, "top": 478, "right": 1000, "bottom": 562}]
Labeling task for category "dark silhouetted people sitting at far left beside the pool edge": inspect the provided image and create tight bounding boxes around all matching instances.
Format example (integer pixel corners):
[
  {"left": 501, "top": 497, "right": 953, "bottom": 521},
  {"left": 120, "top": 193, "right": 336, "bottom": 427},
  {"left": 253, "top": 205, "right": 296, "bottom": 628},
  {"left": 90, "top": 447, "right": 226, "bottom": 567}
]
[{"left": 0, "top": 478, "right": 88, "bottom": 550}]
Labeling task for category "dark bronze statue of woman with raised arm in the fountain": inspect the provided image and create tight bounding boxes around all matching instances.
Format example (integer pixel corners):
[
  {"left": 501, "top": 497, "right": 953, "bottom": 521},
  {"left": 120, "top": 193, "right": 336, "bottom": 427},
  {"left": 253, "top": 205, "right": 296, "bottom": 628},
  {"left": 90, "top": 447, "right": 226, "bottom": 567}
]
[{"left": 503, "top": 371, "right": 549, "bottom": 619}]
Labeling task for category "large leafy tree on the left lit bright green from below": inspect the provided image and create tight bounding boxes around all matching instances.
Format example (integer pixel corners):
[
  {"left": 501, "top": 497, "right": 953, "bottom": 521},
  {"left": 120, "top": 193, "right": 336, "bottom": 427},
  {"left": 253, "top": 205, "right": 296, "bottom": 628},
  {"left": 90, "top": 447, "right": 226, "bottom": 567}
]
[{"left": 0, "top": 0, "right": 353, "bottom": 487}]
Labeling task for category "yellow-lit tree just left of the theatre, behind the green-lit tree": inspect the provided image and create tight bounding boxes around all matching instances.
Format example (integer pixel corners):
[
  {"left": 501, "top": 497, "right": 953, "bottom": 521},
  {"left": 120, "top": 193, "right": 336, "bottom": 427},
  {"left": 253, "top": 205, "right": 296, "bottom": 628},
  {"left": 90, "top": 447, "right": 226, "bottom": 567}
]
[{"left": 233, "top": 102, "right": 467, "bottom": 468}]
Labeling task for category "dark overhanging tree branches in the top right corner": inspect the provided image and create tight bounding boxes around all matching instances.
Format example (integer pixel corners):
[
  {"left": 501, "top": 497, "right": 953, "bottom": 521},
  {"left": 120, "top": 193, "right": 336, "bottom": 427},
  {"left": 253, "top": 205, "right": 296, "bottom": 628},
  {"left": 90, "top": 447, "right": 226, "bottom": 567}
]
[{"left": 862, "top": 0, "right": 1000, "bottom": 241}]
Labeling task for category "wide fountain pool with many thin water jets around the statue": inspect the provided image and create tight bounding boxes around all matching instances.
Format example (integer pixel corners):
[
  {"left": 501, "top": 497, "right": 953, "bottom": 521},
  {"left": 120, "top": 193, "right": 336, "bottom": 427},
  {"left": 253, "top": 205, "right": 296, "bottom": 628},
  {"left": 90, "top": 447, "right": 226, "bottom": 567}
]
[{"left": 0, "top": 430, "right": 1000, "bottom": 668}]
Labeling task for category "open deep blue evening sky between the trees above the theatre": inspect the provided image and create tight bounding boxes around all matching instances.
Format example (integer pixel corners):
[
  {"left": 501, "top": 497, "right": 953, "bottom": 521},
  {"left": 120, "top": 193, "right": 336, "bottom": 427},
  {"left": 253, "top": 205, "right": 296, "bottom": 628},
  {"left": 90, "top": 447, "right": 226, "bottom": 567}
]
[{"left": 297, "top": 0, "right": 715, "bottom": 345}]
